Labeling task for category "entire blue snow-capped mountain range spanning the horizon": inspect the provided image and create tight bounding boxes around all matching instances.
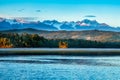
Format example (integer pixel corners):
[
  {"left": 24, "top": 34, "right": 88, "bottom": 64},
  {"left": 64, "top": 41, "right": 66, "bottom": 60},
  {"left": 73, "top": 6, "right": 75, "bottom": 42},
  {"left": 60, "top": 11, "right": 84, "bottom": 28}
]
[{"left": 0, "top": 18, "right": 120, "bottom": 32}]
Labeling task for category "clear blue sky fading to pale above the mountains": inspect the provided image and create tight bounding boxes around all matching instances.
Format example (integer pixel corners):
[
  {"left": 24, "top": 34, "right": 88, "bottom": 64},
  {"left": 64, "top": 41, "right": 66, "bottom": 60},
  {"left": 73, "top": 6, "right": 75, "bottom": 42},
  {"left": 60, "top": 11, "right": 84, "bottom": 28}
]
[{"left": 0, "top": 0, "right": 120, "bottom": 27}]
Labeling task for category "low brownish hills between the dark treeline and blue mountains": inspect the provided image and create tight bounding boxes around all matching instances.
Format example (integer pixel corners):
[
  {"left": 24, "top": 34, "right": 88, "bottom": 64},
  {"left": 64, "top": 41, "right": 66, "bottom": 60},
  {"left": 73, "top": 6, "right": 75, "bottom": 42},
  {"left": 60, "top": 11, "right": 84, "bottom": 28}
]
[{"left": 1, "top": 28, "right": 120, "bottom": 42}]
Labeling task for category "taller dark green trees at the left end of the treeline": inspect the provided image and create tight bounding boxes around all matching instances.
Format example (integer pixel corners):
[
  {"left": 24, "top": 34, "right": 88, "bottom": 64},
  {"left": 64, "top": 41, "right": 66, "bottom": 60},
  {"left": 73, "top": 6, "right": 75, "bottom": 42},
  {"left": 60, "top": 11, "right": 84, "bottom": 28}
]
[{"left": 0, "top": 33, "right": 46, "bottom": 48}]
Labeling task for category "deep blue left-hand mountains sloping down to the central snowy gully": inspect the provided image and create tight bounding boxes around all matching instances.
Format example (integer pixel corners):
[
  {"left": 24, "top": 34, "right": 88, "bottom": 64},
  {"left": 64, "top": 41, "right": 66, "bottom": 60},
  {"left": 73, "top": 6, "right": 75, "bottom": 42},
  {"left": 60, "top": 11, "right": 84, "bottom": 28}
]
[{"left": 0, "top": 19, "right": 58, "bottom": 30}]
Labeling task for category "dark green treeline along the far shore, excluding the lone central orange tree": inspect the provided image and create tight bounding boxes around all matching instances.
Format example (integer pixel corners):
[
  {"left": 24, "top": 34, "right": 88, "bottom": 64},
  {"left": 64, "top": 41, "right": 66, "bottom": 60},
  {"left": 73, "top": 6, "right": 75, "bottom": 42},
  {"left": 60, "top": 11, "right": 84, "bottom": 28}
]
[{"left": 0, "top": 33, "right": 120, "bottom": 48}]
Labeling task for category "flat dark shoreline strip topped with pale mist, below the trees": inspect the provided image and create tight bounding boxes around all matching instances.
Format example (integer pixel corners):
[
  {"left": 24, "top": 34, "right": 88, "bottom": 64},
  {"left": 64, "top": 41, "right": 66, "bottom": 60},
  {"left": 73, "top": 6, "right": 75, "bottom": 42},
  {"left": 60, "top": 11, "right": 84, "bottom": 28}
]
[{"left": 0, "top": 48, "right": 120, "bottom": 56}]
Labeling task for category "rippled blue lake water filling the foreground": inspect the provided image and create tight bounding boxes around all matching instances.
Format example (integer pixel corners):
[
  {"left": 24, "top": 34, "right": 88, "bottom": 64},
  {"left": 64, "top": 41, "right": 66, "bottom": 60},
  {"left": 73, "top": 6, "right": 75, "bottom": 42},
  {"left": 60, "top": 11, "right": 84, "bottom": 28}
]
[{"left": 0, "top": 55, "right": 120, "bottom": 80}]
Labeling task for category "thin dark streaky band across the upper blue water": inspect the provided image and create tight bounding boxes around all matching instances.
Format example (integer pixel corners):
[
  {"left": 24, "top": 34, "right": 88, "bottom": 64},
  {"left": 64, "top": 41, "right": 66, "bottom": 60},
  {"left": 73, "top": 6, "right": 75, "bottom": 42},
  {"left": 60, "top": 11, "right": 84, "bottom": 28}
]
[{"left": 0, "top": 58, "right": 120, "bottom": 67}]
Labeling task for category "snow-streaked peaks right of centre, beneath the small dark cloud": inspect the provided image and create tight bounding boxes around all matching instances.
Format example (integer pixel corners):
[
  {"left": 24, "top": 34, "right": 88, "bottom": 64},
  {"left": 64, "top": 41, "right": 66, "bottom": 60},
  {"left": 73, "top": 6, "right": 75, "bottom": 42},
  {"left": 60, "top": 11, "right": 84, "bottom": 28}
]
[{"left": 43, "top": 19, "right": 111, "bottom": 30}]
